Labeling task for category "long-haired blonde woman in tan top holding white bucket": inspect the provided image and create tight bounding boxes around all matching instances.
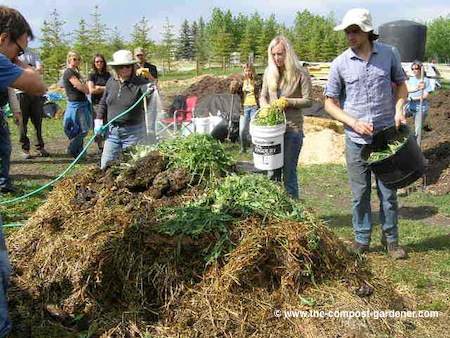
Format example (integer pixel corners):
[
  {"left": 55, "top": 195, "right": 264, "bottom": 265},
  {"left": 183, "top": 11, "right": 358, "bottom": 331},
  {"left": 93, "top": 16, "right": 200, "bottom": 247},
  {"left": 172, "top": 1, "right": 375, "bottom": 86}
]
[{"left": 260, "top": 36, "right": 312, "bottom": 198}]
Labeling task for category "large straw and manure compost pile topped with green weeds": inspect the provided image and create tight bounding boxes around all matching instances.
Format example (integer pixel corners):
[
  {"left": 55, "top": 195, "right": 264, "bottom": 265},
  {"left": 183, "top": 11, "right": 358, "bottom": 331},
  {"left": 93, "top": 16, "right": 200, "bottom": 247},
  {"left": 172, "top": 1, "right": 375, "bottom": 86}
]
[{"left": 8, "top": 134, "right": 429, "bottom": 337}]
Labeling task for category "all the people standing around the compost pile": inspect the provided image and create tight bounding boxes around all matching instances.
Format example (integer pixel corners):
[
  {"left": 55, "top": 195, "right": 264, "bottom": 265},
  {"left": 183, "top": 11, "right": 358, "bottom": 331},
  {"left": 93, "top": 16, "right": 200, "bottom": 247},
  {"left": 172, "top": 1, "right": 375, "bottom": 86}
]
[{"left": 0, "top": 6, "right": 432, "bottom": 336}]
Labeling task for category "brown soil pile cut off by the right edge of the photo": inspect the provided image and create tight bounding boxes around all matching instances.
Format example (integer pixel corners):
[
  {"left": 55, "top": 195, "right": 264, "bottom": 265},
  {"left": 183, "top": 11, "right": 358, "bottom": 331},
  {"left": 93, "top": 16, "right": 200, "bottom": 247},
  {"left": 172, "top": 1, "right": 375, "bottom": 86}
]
[{"left": 422, "top": 90, "right": 450, "bottom": 195}]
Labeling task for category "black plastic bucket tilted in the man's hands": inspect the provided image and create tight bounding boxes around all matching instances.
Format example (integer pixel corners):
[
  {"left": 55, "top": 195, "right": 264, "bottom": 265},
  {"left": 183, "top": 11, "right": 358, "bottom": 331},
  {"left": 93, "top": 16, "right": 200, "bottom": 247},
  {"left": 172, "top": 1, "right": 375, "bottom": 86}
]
[{"left": 361, "top": 125, "right": 425, "bottom": 189}]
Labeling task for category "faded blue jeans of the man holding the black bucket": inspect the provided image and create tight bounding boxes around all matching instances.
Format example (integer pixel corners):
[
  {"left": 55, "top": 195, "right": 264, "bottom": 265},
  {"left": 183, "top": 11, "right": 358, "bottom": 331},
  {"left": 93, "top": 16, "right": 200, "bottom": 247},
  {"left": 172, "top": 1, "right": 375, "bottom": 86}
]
[{"left": 345, "top": 137, "right": 398, "bottom": 245}]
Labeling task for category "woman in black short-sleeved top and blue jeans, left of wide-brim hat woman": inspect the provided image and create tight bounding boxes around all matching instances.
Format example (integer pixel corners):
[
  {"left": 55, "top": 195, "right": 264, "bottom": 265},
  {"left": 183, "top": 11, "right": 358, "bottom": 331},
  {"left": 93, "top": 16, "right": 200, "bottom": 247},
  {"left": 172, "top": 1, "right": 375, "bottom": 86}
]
[{"left": 62, "top": 51, "right": 92, "bottom": 158}]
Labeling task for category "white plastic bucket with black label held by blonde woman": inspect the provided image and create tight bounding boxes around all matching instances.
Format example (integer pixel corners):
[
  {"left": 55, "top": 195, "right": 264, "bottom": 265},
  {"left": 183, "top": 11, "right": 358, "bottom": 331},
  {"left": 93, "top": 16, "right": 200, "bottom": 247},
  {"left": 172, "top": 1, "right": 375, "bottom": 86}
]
[{"left": 250, "top": 119, "right": 286, "bottom": 170}]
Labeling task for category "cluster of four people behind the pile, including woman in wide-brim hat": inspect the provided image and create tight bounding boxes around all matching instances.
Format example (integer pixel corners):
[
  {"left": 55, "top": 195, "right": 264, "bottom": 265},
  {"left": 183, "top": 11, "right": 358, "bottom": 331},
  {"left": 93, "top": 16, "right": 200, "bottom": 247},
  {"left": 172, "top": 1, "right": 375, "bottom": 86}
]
[{"left": 62, "top": 48, "right": 158, "bottom": 168}]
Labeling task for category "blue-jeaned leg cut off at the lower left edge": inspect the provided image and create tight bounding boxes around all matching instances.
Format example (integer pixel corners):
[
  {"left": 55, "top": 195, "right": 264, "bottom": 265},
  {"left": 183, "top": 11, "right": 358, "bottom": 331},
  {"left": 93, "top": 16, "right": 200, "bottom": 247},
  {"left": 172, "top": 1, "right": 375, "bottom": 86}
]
[{"left": 0, "top": 217, "right": 11, "bottom": 337}]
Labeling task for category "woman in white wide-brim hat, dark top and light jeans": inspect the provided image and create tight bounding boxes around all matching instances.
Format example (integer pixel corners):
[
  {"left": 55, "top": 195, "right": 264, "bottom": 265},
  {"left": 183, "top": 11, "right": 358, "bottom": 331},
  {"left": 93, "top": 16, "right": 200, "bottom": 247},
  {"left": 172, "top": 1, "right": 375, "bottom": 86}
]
[{"left": 95, "top": 50, "right": 148, "bottom": 169}]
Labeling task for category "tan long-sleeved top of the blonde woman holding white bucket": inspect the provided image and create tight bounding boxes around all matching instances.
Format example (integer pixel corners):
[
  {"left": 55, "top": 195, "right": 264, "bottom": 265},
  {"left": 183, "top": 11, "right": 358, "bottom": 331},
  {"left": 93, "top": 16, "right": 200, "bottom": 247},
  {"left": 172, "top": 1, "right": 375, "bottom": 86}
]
[{"left": 259, "top": 67, "right": 313, "bottom": 131}]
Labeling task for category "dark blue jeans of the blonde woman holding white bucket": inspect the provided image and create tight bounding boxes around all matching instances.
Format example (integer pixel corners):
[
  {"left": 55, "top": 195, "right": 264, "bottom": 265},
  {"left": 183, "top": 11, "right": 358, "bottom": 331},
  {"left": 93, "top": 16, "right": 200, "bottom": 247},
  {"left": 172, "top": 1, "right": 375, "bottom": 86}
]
[{"left": 267, "top": 131, "right": 303, "bottom": 199}]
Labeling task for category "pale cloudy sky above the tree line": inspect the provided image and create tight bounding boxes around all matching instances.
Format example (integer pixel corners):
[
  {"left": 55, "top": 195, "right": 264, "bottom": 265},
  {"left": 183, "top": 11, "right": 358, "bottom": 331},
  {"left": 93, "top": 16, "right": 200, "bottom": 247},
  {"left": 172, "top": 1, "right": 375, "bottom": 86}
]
[{"left": 1, "top": 0, "right": 450, "bottom": 46}]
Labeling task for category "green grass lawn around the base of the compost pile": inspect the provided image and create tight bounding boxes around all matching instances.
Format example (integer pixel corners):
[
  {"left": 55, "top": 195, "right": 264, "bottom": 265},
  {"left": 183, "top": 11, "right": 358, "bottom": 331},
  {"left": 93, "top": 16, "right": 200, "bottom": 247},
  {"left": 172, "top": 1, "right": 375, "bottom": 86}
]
[{"left": 0, "top": 109, "right": 450, "bottom": 336}]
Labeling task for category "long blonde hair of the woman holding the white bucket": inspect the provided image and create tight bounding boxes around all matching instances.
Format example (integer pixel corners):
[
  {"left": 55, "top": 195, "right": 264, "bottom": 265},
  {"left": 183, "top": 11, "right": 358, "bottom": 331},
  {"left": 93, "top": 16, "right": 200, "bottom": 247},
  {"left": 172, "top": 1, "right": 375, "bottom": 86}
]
[{"left": 264, "top": 35, "right": 302, "bottom": 92}]
